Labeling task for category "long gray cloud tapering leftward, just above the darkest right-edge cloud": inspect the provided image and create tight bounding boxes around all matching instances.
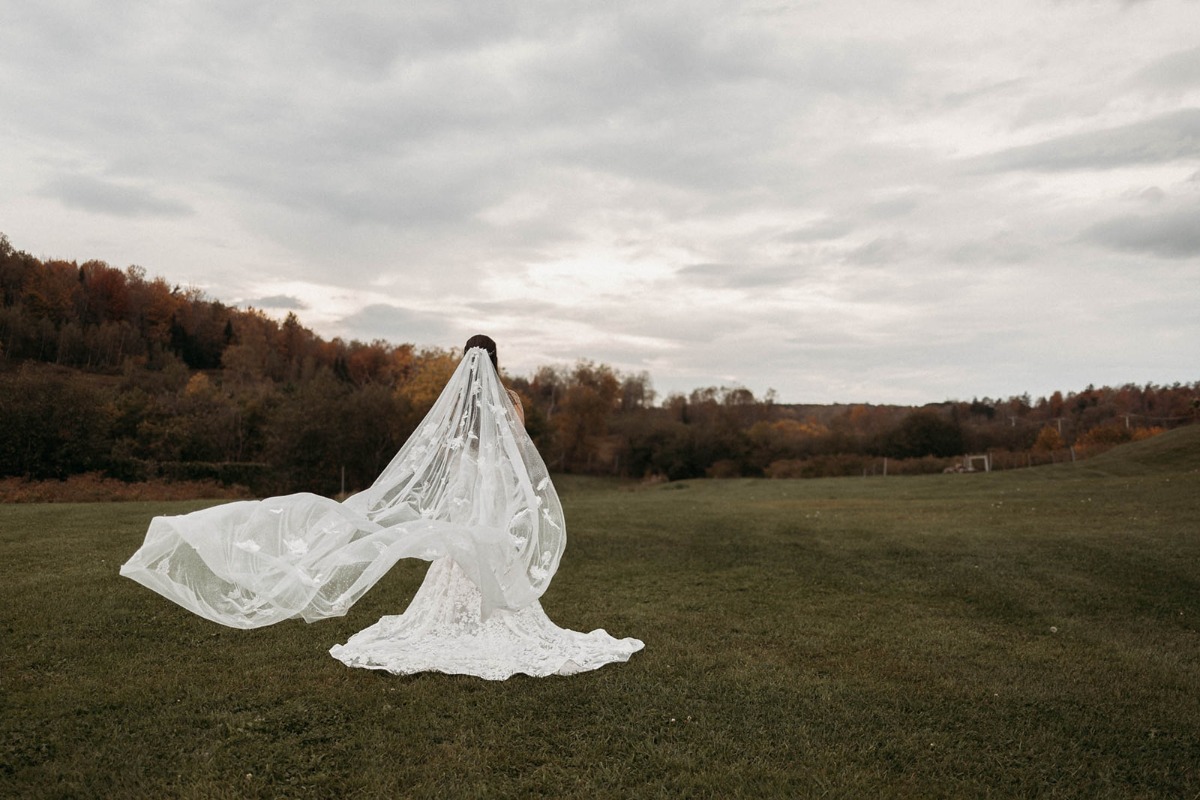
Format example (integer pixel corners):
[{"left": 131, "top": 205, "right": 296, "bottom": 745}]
[{"left": 973, "top": 108, "right": 1200, "bottom": 172}]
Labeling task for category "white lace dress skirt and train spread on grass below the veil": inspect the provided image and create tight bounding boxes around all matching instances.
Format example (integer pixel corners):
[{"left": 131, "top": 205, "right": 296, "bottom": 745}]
[{"left": 330, "top": 558, "right": 642, "bottom": 680}]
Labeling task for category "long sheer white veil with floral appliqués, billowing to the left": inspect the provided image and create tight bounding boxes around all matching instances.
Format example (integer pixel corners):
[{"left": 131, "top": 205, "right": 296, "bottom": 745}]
[{"left": 121, "top": 348, "right": 566, "bottom": 628}]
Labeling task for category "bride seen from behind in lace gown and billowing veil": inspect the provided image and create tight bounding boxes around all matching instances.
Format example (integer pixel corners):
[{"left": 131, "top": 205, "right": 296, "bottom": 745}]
[{"left": 121, "top": 336, "right": 642, "bottom": 680}]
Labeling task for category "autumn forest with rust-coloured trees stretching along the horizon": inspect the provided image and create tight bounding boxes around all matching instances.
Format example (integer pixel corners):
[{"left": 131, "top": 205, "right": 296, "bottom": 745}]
[{"left": 0, "top": 234, "right": 1200, "bottom": 494}]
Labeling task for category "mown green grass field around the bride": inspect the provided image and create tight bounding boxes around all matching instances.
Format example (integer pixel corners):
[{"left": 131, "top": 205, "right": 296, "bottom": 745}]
[{"left": 0, "top": 426, "right": 1200, "bottom": 798}]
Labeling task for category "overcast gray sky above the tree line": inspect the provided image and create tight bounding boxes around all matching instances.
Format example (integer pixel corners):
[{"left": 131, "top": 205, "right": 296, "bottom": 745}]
[{"left": 0, "top": 0, "right": 1200, "bottom": 403}]
